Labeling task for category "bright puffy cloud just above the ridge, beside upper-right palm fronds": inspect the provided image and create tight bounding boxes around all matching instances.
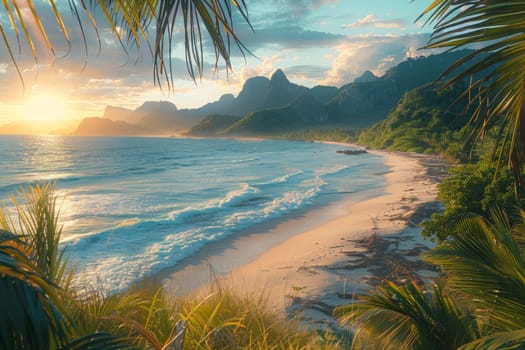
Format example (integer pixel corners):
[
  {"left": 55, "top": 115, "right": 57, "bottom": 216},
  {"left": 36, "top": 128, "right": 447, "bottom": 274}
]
[{"left": 321, "top": 34, "right": 437, "bottom": 86}]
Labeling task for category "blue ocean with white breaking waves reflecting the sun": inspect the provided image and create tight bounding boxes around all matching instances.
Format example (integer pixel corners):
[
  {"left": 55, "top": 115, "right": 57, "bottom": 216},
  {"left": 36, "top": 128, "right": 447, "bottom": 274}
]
[{"left": 0, "top": 136, "right": 388, "bottom": 291}]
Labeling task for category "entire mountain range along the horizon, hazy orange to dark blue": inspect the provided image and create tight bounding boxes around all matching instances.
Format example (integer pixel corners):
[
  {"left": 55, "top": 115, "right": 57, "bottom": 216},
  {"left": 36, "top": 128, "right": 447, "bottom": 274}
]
[{"left": 0, "top": 52, "right": 470, "bottom": 137}]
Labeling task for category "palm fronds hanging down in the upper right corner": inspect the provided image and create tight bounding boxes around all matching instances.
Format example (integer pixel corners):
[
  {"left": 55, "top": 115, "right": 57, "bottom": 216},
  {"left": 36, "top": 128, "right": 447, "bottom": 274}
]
[{"left": 421, "top": 0, "right": 525, "bottom": 186}]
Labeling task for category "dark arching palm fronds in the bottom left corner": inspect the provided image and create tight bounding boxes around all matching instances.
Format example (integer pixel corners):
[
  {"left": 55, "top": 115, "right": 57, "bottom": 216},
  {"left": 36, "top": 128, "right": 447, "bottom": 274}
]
[{"left": 0, "top": 236, "right": 70, "bottom": 349}]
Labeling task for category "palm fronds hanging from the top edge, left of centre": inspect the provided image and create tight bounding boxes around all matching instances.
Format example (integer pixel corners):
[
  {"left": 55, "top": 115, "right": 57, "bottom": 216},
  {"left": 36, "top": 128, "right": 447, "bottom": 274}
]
[{"left": 0, "top": 0, "right": 250, "bottom": 88}]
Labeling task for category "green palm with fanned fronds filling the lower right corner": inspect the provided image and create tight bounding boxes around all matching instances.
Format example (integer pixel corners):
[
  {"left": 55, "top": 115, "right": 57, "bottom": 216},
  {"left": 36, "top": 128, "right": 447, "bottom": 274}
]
[{"left": 336, "top": 211, "right": 525, "bottom": 349}]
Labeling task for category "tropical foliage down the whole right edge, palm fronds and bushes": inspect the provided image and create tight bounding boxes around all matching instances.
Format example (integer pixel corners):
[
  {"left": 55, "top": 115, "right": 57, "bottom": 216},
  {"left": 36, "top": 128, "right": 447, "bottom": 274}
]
[{"left": 336, "top": 0, "right": 525, "bottom": 349}]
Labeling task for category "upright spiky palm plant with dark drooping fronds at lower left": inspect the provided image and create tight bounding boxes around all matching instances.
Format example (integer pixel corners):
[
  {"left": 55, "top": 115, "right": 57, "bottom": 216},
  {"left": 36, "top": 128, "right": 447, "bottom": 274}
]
[{"left": 0, "top": 184, "right": 135, "bottom": 349}]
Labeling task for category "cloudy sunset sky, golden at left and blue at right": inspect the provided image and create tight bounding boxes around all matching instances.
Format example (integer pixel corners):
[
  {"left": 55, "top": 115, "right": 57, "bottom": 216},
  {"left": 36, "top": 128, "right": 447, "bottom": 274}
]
[{"left": 0, "top": 0, "right": 432, "bottom": 125}]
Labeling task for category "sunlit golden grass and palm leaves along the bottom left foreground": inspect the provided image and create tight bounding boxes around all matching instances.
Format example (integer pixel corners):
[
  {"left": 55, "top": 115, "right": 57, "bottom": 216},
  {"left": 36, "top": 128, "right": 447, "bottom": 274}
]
[{"left": 0, "top": 183, "right": 338, "bottom": 349}]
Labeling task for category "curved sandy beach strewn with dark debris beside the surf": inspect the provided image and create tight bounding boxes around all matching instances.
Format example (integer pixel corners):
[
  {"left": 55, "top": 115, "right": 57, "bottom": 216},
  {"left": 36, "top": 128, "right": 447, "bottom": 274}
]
[{"left": 156, "top": 144, "right": 445, "bottom": 325}]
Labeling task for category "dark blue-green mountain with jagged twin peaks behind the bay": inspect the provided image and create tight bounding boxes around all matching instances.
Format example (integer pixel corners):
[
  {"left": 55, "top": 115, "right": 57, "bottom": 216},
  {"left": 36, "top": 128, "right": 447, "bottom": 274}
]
[{"left": 190, "top": 51, "right": 465, "bottom": 136}]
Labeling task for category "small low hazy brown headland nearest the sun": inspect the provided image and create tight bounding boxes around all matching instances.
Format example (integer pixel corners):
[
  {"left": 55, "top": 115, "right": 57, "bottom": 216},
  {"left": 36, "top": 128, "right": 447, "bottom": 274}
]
[{"left": 73, "top": 117, "right": 158, "bottom": 136}]
